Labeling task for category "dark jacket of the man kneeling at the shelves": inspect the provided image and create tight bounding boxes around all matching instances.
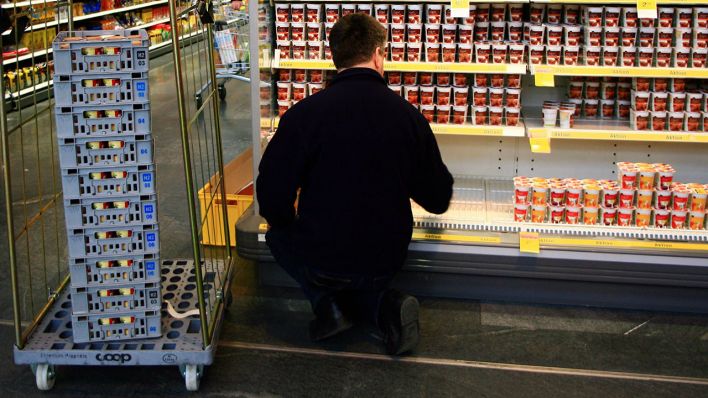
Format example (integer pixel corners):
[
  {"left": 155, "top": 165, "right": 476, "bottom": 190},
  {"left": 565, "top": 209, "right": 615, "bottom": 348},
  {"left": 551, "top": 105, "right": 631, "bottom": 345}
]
[{"left": 256, "top": 68, "right": 453, "bottom": 275}]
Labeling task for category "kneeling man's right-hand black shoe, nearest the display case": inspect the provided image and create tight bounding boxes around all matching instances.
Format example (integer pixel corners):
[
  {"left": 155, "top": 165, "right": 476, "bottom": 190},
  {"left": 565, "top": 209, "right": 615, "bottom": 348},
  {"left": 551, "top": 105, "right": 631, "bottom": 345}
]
[{"left": 379, "top": 289, "right": 420, "bottom": 355}]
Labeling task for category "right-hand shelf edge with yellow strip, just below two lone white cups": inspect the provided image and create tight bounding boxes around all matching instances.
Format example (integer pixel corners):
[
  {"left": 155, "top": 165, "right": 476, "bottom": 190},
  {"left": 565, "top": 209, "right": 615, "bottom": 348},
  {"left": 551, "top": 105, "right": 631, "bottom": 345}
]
[{"left": 524, "top": 115, "right": 708, "bottom": 144}]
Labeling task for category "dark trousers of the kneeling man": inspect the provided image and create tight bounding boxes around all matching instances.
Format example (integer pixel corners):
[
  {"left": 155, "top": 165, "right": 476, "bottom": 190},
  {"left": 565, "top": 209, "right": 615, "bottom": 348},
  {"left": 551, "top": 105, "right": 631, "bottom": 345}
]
[{"left": 266, "top": 228, "right": 395, "bottom": 325}]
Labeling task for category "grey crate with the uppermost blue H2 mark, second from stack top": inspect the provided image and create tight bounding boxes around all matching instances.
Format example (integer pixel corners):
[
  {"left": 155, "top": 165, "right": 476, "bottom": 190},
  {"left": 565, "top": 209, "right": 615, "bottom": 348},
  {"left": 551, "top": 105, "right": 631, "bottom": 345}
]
[{"left": 54, "top": 72, "right": 150, "bottom": 106}]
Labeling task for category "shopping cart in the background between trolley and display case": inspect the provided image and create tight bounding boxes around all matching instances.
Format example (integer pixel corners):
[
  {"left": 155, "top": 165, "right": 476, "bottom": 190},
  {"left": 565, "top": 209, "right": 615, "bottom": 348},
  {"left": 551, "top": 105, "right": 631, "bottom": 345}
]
[{"left": 195, "top": 4, "right": 250, "bottom": 107}]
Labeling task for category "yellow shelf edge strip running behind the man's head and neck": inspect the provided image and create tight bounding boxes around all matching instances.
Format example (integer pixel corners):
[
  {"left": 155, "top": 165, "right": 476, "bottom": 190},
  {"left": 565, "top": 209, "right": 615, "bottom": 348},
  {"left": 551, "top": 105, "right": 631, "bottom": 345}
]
[{"left": 271, "top": 59, "right": 526, "bottom": 74}]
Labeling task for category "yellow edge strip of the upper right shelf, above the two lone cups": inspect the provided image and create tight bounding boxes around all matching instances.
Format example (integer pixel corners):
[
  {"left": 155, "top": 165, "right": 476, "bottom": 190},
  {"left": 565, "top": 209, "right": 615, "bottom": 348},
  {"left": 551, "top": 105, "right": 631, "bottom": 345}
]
[{"left": 529, "top": 65, "right": 708, "bottom": 79}]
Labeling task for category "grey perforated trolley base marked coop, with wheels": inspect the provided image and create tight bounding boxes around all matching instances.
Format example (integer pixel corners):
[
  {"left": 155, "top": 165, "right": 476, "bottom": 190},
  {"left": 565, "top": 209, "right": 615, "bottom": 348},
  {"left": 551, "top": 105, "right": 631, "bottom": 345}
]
[{"left": 14, "top": 260, "right": 231, "bottom": 390}]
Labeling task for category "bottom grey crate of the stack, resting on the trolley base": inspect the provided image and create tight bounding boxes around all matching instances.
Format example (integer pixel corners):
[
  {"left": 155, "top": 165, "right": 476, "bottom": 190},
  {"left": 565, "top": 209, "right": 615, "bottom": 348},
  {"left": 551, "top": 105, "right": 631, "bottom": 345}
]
[{"left": 71, "top": 311, "right": 162, "bottom": 343}]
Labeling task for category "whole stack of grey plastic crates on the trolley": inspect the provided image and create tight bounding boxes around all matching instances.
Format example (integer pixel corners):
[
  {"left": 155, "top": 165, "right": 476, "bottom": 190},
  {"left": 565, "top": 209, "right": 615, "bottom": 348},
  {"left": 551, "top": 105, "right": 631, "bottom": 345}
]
[{"left": 53, "top": 30, "right": 161, "bottom": 343}]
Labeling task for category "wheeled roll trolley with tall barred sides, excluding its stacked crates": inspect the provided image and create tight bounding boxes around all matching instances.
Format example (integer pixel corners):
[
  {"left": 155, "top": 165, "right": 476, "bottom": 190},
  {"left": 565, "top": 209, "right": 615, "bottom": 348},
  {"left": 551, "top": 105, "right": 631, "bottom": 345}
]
[{"left": 0, "top": 0, "right": 233, "bottom": 391}]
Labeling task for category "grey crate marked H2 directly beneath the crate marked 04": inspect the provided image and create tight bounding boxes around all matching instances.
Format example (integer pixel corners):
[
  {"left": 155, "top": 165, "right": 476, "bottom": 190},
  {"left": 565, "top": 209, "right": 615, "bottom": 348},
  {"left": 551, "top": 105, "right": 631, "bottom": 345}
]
[{"left": 62, "top": 166, "right": 155, "bottom": 199}]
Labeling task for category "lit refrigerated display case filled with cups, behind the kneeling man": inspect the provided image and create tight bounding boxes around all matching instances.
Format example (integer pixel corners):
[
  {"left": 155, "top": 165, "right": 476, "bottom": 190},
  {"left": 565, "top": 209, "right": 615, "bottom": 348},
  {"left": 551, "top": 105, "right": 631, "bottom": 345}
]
[{"left": 237, "top": 0, "right": 708, "bottom": 312}]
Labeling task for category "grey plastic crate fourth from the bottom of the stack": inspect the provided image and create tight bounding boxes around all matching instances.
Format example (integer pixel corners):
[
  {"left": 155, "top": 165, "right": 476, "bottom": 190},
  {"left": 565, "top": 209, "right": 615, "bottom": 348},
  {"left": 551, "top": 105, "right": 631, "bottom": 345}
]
[{"left": 67, "top": 225, "right": 160, "bottom": 258}]
